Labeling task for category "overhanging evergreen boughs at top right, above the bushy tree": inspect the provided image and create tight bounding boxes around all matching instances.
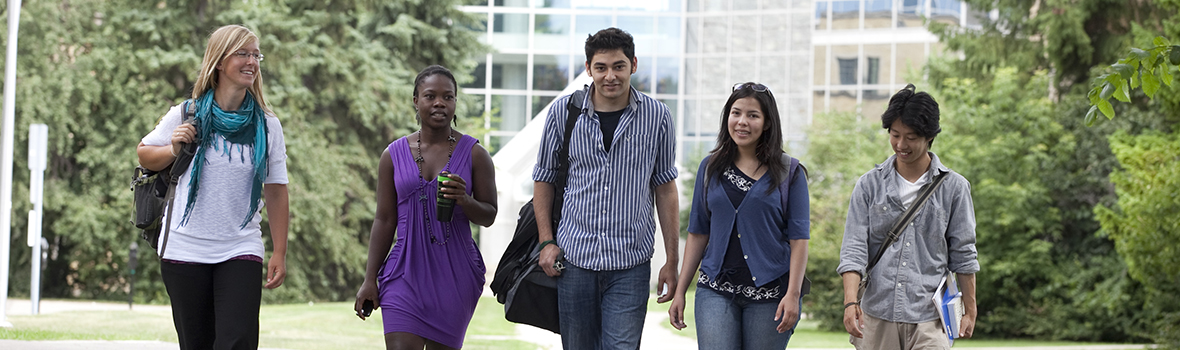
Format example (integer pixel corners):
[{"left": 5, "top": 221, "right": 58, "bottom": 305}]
[{"left": 930, "top": 0, "right": 1174, "bottom": 97}]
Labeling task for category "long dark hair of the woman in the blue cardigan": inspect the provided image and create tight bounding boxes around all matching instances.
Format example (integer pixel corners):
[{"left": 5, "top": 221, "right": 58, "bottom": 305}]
[{"left": 704, "top": 82, "right": 786, "bottom": 193}]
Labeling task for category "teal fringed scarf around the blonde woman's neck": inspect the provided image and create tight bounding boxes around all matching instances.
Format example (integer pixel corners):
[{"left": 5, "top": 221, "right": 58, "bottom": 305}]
[{"left": 181, "top": 90, "right": 268, "bottom": 227}]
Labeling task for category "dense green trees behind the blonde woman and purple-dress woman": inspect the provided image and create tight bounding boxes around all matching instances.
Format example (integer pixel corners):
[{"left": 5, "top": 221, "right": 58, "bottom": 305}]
[{"left": 1, "top": 0, "right": 487, "bottom": 302}]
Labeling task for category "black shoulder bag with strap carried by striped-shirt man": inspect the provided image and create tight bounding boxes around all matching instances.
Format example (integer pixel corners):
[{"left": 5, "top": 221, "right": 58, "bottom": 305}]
[{"left": 490, "top": 90, "right": 585, "bottom": 334}]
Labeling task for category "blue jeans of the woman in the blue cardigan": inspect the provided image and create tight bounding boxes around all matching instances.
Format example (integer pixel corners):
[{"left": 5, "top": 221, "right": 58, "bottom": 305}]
[{"left": 694, "top": 288, "right": 802, "bottom": 350}]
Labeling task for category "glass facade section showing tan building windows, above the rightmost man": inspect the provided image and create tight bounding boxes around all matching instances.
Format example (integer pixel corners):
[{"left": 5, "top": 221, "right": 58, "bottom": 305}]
[{"left": 811, "top": 0, "right": 978, "bottom": 118}]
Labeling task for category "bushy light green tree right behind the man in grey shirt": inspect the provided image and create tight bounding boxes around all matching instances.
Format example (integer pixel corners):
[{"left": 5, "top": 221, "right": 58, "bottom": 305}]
[{"left": 931, "top": 62, "right": 1141, "bottom": 341}]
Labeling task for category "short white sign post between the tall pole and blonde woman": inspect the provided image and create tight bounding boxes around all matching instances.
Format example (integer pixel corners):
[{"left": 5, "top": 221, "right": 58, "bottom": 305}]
[{"left": 28, "top": 124, "right": 50, "bottom": 315}]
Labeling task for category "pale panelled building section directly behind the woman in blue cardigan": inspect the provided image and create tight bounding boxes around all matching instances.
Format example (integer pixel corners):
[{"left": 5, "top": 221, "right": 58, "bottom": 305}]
[{"left": 680, "top": 0, "right": 812, "bottom": 158}]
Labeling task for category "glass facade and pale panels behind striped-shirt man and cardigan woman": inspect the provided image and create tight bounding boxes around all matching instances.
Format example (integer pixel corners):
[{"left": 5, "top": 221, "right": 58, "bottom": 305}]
[{"left": 464, "top": 0, "right": 812, "bottom": 160}]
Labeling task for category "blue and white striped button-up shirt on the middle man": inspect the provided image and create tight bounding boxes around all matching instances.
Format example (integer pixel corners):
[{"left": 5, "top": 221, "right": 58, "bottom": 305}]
[{"left": 532, "top": 86, "right": 676, "bottom": 271}]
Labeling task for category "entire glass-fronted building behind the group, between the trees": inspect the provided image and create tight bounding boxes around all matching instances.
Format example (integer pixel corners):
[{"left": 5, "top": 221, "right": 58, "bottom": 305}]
[{"left": 463, "top": 0, "right": 972, "bottom": 161}]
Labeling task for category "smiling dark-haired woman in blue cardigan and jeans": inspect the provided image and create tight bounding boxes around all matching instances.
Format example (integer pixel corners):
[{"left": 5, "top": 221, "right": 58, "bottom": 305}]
[{"left": 668, "top": 82, "right": 811, "bottom": 349}]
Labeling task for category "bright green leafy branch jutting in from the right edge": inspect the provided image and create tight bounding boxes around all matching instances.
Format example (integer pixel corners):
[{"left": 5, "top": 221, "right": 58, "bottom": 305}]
[{"left": 1086, "top": 37, "right": 1180, "bottom": 126}]
